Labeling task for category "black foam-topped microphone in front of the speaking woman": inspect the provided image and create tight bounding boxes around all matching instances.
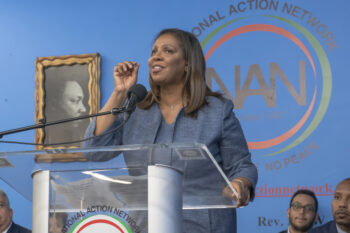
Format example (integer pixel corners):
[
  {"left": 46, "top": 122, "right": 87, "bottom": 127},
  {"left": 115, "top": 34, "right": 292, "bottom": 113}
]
[{"left": 124, "top": 84, "right": 147, "bottom": 122}]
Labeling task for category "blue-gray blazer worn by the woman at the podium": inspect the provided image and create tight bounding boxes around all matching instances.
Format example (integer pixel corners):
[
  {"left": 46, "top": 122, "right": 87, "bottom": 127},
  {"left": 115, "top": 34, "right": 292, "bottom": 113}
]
[{"left": 85, "top": 97, "right": 257, "bottom": 233}]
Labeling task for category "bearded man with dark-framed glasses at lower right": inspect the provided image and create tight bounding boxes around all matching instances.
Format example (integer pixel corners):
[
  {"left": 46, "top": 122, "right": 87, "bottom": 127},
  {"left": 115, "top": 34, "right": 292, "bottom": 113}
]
[{"left": 280, "top": 189, "right": 318, "bottom": 233}]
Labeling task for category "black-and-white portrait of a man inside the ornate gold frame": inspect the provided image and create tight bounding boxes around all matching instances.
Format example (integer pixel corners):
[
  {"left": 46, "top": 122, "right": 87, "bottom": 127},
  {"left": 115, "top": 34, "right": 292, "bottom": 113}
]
[{"left": 44, "top": 64, "right": 90, "bottom": 147}]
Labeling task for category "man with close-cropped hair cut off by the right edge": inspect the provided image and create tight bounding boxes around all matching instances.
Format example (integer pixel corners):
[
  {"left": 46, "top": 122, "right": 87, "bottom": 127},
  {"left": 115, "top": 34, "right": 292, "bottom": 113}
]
[{"left": 310, "top": 178, "right": 350, "bottom": 233}]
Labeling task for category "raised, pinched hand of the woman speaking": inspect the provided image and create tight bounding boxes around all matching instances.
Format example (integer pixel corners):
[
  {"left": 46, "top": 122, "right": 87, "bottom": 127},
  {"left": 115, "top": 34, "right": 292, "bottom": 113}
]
[{"left": 113, "top": 61, "right": 140, "bottom": 92}]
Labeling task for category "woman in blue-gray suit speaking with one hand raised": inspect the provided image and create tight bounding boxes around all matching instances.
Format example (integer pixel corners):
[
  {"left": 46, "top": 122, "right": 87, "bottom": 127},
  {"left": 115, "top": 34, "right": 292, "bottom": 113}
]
[{"left": 86, "top": 29, "right": 257, "bottom": 233}]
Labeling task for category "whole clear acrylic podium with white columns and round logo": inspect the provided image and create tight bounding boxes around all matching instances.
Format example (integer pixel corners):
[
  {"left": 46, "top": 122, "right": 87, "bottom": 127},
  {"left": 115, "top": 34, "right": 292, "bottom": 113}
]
[{"left": 0, "top": 143, "right": 236, "bottom": 233}]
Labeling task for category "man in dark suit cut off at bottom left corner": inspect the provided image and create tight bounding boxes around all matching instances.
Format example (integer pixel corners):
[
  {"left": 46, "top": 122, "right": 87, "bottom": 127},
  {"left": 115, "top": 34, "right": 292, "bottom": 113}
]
[{"left": 0, "top": 189, "right": 31, "bottom": 233}]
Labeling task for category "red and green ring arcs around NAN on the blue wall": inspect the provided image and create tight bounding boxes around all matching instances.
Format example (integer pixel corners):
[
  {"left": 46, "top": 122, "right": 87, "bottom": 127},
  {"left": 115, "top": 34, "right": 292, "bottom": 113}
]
[{"left": 201, "top": 16, "right": 332, "bottom": 156}]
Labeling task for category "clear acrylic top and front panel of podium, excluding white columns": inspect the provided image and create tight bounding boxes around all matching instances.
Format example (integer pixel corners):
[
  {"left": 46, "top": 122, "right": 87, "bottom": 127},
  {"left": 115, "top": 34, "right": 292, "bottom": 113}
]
[{"left": 0, "top": 144, "right": 235, "bottom": 232}]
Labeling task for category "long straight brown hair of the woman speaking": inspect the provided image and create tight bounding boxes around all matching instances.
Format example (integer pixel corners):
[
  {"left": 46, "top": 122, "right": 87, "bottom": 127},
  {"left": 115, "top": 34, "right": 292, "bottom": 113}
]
[{"left": 139, "top": 28, "right": 221, "bottom": 117}]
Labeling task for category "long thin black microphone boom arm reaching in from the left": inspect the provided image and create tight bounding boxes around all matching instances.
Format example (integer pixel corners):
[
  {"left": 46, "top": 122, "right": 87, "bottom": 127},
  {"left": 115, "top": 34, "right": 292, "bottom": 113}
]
[{"left": 0, "top": 107, "right": 127, "bottom": 138}]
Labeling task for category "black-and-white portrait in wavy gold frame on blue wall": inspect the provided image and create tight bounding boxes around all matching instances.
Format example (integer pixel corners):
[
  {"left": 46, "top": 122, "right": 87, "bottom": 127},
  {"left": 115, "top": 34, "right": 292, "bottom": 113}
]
[{"left": 35, "top": 53, "right": 101, "bottom": 162}]
